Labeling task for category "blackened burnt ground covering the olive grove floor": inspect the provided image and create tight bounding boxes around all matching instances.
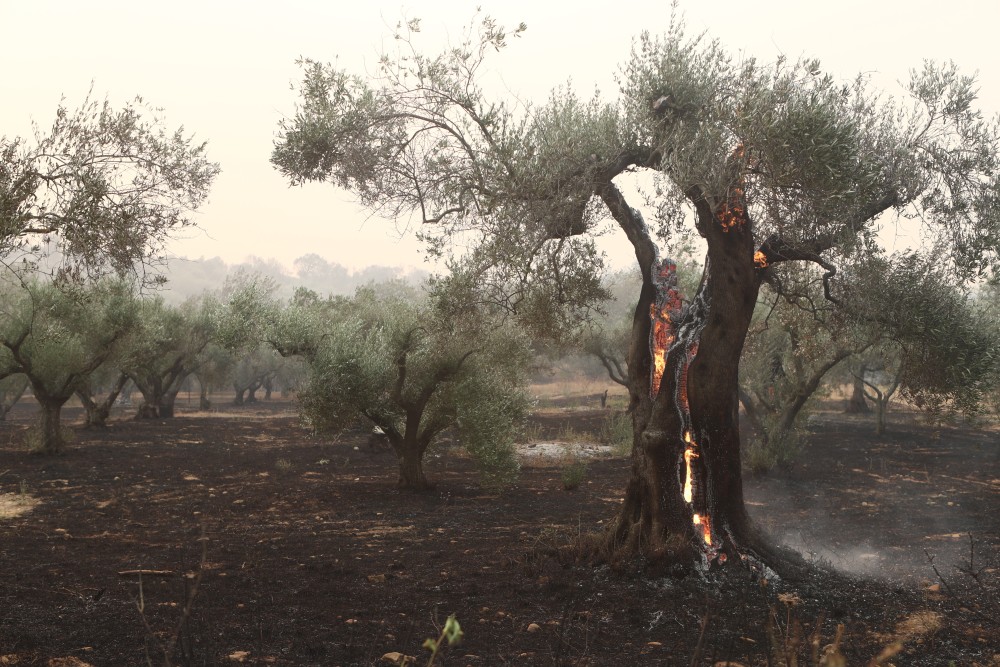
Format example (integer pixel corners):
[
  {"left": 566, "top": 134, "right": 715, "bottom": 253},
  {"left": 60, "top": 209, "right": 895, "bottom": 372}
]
[{"left": 0, "top": 402, "right": 1000, "bottom": 665}]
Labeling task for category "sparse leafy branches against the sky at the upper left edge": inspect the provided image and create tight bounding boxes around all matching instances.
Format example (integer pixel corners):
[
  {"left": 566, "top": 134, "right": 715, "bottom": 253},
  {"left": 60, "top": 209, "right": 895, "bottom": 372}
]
[{"left": 0, "top": 91, "right": 219, "bottom": 277}]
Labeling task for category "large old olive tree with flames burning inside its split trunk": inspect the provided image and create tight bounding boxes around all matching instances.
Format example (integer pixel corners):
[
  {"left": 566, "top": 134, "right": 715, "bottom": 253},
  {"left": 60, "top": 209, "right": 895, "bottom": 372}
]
[{"left": 272, "top": 19, "right": 1000, "bottom": 572}]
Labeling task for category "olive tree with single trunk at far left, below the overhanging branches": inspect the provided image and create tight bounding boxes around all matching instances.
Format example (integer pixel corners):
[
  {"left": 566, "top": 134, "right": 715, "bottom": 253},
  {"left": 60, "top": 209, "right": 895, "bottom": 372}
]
[{"left": 0, "top": 279, "right": 138, "bottom": 454}]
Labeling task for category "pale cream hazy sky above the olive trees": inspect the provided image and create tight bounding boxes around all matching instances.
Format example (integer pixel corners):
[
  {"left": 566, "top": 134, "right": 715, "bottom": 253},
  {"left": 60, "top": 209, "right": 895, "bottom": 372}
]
[{"left": 0, "top": 0, "right": 1000, "bottom": 268}]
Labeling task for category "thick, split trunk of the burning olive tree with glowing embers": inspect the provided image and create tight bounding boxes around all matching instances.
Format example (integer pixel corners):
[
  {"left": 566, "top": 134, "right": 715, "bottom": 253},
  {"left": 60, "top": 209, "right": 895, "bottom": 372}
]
[{"left": 606, "top": 187, "right": 802, "bottom": 574}]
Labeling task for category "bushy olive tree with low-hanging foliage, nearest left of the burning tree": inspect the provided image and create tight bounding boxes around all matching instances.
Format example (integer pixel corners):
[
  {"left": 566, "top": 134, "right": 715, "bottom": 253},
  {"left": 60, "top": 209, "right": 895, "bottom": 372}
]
[{"left": 276, "top": 284, "right": 532, "bottom": 490}]
